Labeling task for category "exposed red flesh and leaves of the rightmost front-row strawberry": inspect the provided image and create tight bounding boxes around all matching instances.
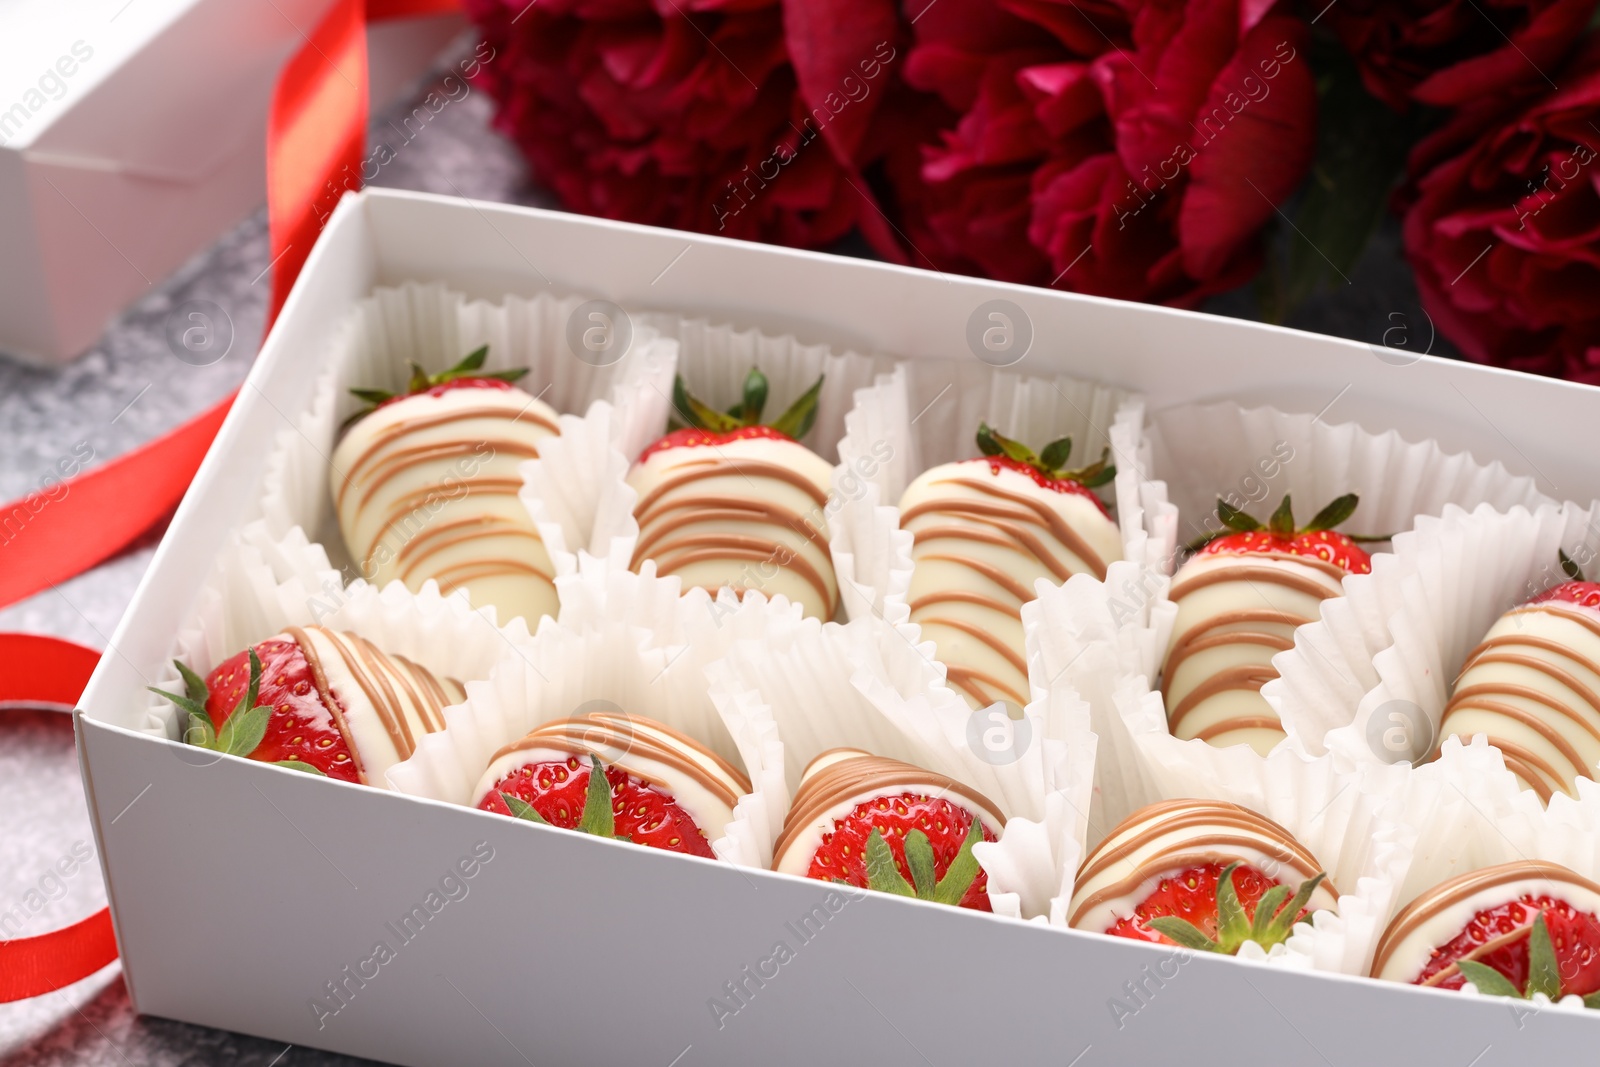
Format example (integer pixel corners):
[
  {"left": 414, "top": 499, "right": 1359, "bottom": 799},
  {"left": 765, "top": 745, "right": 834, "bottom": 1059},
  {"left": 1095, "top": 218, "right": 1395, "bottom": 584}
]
[{"left": 1413, "top": 894, "right": 1600, "bottom": 1008}]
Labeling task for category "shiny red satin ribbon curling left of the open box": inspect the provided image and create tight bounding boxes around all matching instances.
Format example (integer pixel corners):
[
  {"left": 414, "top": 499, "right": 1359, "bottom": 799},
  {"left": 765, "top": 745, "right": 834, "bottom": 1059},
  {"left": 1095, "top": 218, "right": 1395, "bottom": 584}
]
[{"left": 0, "top": 0, "right": 459, "bottom": 1003}]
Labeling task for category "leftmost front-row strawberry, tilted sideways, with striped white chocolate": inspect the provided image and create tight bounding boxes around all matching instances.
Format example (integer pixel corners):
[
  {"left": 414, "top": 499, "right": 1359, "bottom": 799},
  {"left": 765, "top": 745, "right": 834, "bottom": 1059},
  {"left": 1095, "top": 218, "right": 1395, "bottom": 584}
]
[{"left": 152, "top": 625, "right": 464, "bottom": 785}]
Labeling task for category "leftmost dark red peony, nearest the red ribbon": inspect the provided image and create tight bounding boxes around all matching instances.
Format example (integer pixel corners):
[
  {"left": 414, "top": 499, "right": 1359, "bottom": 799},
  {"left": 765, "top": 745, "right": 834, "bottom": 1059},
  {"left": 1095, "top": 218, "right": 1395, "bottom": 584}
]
[{"left": 466, "top": 0, "right": 936, "bottom": 259}]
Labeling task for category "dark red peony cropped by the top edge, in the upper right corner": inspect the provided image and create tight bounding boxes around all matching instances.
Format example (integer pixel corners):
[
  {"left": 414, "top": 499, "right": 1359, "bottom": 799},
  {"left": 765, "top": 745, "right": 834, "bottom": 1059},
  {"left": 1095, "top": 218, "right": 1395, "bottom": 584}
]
[{"left": 1312, "top": 0, "right": 1600, "bottom": 110}]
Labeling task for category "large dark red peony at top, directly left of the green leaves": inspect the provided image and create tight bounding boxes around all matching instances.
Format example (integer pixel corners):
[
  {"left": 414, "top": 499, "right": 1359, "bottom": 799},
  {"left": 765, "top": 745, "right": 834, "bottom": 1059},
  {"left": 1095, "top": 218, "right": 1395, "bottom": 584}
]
[{"left": 906, "top": 0, "right": 1315, "bottom": 306}]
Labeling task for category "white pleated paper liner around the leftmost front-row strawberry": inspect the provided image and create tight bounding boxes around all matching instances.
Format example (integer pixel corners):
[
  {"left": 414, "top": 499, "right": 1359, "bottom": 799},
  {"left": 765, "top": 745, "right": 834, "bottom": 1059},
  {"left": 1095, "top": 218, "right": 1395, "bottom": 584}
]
[{"left": 146, "top": 522, "right": 530, "bottom": 755}]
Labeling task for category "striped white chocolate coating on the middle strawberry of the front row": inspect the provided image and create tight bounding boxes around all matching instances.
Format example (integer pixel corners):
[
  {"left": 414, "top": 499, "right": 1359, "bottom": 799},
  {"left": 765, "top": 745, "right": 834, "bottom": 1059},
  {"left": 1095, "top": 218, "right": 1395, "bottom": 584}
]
[{"left": 773, "top": 749, "right": 1005, "bottom": 878}]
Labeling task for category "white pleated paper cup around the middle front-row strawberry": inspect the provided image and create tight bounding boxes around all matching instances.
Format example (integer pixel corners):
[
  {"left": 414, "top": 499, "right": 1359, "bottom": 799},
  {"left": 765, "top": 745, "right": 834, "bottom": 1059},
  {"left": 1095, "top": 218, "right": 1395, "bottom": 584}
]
[{"left": 709, "top": 616, "right": 1094, "bottom": 918}]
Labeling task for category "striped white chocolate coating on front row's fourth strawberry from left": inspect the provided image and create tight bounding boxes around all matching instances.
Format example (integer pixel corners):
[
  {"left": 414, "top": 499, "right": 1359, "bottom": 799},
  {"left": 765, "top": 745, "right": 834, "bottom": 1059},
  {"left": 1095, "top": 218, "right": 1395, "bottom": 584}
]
[{"left": 1067, "top": 800, "right": 1339, "bottom": 933}]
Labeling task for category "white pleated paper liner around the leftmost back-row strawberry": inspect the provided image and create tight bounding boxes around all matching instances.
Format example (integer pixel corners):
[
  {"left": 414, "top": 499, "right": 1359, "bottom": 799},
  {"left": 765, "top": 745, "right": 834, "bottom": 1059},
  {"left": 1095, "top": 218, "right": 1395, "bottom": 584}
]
[{"left": 261, "top": 283, "right": 677, "bottom": 598}]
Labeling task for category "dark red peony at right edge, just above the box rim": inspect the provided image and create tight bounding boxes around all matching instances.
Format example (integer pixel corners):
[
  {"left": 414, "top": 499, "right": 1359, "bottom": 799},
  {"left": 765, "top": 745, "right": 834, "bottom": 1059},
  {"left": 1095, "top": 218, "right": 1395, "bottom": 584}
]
[{"left": 1405, "top": 35, "right": 1600, "bottom": 384}]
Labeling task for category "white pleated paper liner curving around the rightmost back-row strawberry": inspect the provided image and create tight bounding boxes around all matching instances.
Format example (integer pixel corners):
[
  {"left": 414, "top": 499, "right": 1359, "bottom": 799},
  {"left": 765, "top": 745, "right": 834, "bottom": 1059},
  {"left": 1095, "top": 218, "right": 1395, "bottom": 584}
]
[{"left": 1262, "top": 504, "right": 1600, "bottom": 763}]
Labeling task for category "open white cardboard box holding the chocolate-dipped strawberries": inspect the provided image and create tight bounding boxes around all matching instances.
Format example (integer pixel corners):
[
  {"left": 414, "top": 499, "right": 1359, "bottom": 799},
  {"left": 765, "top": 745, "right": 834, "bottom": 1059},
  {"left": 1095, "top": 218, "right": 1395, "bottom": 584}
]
[{"left": 77, "top": 190, "right": 1600, "bottom": 1067}]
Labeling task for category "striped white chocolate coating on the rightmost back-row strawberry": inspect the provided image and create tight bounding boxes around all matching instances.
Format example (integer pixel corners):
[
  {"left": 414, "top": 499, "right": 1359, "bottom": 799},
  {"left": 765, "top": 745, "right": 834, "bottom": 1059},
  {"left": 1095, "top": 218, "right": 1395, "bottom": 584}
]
[{"left": 1440, "top": 601, "right": 1600, "bottom": 801}]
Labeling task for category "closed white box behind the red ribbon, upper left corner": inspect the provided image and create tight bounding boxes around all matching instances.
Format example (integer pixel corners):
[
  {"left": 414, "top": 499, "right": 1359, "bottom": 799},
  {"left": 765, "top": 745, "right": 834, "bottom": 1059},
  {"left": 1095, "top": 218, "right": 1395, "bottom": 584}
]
[{"left": 0, "top": 0, "right": 462, "bottom": 363}]
